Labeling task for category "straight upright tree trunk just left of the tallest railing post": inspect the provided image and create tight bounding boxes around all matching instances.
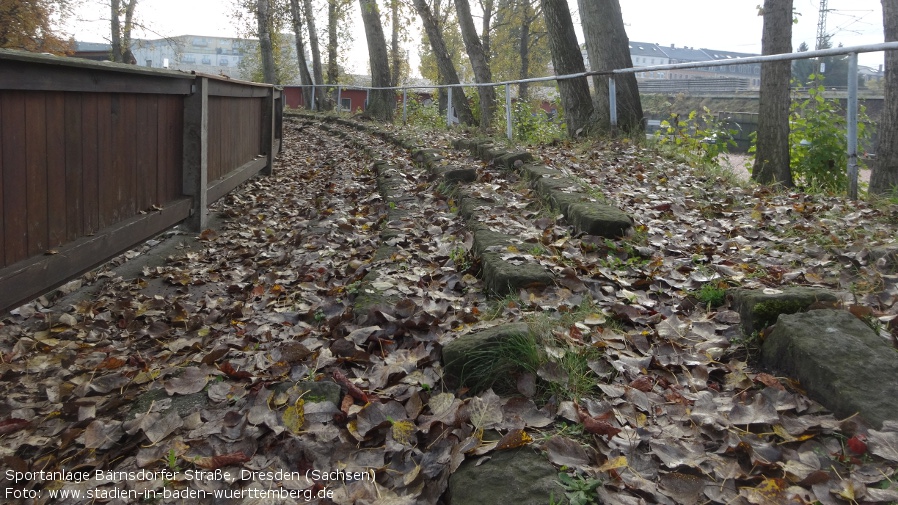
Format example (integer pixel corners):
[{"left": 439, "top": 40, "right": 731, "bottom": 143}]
[{"left": 751, "top": 0, "right": 793, "bottom": 187}]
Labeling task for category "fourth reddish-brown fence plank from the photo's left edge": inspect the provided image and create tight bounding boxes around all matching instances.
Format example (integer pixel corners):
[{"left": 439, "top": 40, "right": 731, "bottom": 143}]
[{"left": 63, "top": 93, "right": 88, "bottom": 241}]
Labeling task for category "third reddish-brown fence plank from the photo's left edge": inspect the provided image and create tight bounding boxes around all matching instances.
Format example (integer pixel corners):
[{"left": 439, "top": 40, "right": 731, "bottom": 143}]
[{"left": 45, "top": 92, "right": 66, "bottom": 249}]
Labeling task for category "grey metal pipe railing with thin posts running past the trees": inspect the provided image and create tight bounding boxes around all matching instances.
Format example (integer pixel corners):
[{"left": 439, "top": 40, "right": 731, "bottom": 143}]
[{"left": 298, "top": 42, "right": 898, "bottom": 199}]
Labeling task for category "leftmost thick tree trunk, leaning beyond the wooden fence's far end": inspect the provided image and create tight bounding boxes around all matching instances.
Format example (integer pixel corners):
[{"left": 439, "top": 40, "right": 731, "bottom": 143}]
[{"left": 359, "top": 0, "right": 396, "bottom": 122}]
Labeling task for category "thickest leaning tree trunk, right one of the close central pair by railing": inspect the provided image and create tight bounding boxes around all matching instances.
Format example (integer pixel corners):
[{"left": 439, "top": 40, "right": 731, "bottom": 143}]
[{"left": 578, "top": 0, "right": 644, "bottom": 133}]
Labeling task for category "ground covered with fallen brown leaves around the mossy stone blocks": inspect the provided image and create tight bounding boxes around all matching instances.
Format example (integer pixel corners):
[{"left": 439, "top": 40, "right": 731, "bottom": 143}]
[{"left": 0, "top": 115, "right": 898, "bottom": 505}]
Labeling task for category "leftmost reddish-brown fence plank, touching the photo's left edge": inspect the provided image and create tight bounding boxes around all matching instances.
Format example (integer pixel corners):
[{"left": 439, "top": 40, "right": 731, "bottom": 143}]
[{"left": 0, "top": 91, "right": 28, "bottom": 265}]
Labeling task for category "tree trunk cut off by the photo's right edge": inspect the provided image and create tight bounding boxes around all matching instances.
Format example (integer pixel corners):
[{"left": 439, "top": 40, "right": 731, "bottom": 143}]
[{"left": 870, "top": 0, "right": 898, "bottom": 195}]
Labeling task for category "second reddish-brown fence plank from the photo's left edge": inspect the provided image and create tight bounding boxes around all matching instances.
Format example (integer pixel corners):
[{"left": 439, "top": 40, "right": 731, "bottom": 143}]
[{"left": 24, "top": 92, "right": 49, "bottom": 256}]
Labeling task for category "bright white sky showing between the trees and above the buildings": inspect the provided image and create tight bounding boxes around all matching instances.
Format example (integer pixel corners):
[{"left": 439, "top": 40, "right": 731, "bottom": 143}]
[{"left": 69, "top": 0, "right": 883, "bottom": 74}]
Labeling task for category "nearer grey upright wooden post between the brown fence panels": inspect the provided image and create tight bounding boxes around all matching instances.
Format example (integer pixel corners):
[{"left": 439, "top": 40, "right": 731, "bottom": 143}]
[{"left": 182, "top": 77, "right": 209, "bottom": 232}]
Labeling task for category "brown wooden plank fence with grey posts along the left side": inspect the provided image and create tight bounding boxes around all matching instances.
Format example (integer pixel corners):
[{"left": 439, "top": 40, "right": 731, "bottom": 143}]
[{"left": 0, "top": 50, "right": 283, "bottom": 311}]
